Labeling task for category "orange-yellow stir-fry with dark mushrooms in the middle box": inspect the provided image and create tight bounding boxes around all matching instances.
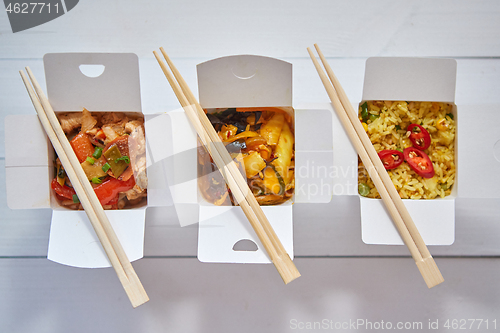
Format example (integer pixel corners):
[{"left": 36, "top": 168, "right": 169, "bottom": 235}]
[{"left": 198, "top": 108, "right": 295, "bottom": 205}]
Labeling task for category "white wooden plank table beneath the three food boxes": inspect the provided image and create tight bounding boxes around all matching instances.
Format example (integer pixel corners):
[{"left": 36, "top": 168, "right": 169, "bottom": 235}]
[{"left": 0, "top": 0, "right": 500, "bottom": 332}]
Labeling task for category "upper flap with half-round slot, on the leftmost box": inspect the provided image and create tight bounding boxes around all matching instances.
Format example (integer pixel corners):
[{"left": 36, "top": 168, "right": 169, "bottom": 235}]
[{"left": 43, "top": 53, "right": 141, "bottom": 112}]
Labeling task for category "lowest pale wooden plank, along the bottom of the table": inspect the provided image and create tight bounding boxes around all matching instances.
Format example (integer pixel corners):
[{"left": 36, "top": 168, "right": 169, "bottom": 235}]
[{"left": 0, "top": 258, "right": 500, "bottom": 333}]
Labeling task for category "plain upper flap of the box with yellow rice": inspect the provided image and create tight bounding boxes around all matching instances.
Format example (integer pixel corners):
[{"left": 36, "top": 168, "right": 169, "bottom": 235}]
[{"left": 363, "top": 57, "right": 457, "bottom": 103}]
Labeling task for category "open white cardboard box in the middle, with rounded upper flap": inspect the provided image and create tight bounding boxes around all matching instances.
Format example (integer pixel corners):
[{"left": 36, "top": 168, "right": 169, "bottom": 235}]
[{"left": 164, "top": 55, "right": 357, "bottom": 263}]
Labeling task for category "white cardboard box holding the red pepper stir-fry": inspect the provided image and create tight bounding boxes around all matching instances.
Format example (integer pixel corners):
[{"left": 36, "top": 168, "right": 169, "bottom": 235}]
[{"left": 5, "top": 53, "right": 170, "bottom": 268}]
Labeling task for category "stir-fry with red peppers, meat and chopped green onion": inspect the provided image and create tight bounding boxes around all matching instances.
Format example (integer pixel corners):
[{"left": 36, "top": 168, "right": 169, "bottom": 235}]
[{"left": 51, "top": 109, "right": 147, "bottom": 209}]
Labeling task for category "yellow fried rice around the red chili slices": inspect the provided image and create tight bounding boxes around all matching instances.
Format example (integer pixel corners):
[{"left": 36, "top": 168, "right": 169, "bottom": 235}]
[{"left": 358, "top": 101, "right": 456, "bottom": 199}]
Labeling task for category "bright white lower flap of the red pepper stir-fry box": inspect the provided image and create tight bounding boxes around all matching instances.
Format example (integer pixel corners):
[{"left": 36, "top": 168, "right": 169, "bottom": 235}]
[{"left": 47, "top": 207, "right": 146, "bottom": 268}]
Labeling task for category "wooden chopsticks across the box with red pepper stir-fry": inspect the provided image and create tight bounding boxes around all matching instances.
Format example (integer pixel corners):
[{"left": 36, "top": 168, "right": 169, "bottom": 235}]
[{"left": 19, "top": 67, "right": 149, "bottom": 308}]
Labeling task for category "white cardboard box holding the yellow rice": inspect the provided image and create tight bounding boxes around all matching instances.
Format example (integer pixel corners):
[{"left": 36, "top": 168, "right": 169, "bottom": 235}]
[{"left": 360, "top": 58, "right": 458, "bottom": 245}]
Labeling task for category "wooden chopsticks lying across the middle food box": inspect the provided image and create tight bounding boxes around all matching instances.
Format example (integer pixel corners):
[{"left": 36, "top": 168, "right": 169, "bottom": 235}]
[{"left": 153, "top": 47, "right": 300, "bottom": 284}]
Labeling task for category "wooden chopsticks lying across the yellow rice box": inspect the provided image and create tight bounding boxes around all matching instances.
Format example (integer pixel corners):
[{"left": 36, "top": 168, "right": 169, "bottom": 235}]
[{"left": 307, "top": 44, "right": 444, "bottom": 288}]
